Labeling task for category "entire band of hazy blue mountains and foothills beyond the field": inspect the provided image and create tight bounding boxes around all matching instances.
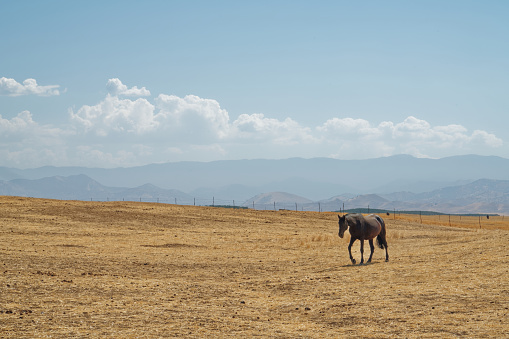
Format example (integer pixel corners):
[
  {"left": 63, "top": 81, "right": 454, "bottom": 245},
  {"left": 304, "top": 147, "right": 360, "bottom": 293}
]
[{"left": 0, "top": 155, "right": 509, "bottom": 214}]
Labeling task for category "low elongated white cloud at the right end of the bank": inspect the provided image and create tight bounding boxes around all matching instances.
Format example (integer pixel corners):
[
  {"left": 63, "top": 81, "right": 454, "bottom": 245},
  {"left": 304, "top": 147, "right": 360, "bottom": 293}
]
[{"left": 317, "top": 116, "right": 503, "bottom": 158}]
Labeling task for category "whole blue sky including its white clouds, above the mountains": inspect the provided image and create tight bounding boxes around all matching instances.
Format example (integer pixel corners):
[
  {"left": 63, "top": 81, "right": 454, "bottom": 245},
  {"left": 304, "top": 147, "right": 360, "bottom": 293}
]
[{"left": 0, "top": 0, "right": 509, "bottom": 168}]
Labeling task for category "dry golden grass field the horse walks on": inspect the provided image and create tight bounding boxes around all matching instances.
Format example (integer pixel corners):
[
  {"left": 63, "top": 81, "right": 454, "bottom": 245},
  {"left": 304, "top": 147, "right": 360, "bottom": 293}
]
[{"left": 0, "top": 197, "right": 509, "bottom": 338}]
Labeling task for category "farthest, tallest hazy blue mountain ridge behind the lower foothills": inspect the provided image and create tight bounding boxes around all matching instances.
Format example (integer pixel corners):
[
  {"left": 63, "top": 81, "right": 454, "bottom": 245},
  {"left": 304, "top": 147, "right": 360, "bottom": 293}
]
[{"left": 0, "top": 155, "right": 509, "bottom": 200}]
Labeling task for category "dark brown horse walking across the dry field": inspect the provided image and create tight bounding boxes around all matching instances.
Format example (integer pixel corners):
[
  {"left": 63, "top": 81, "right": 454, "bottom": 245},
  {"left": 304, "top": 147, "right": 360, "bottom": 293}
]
[{"left": 338, "top": 213, "right": 389, "bottom": 265}]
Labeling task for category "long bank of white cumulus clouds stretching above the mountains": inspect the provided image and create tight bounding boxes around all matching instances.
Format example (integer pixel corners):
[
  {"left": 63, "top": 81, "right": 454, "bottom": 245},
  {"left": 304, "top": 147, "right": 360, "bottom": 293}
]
[{"left": 0, "top": 78, "right": 504, "bottom": 167}]
